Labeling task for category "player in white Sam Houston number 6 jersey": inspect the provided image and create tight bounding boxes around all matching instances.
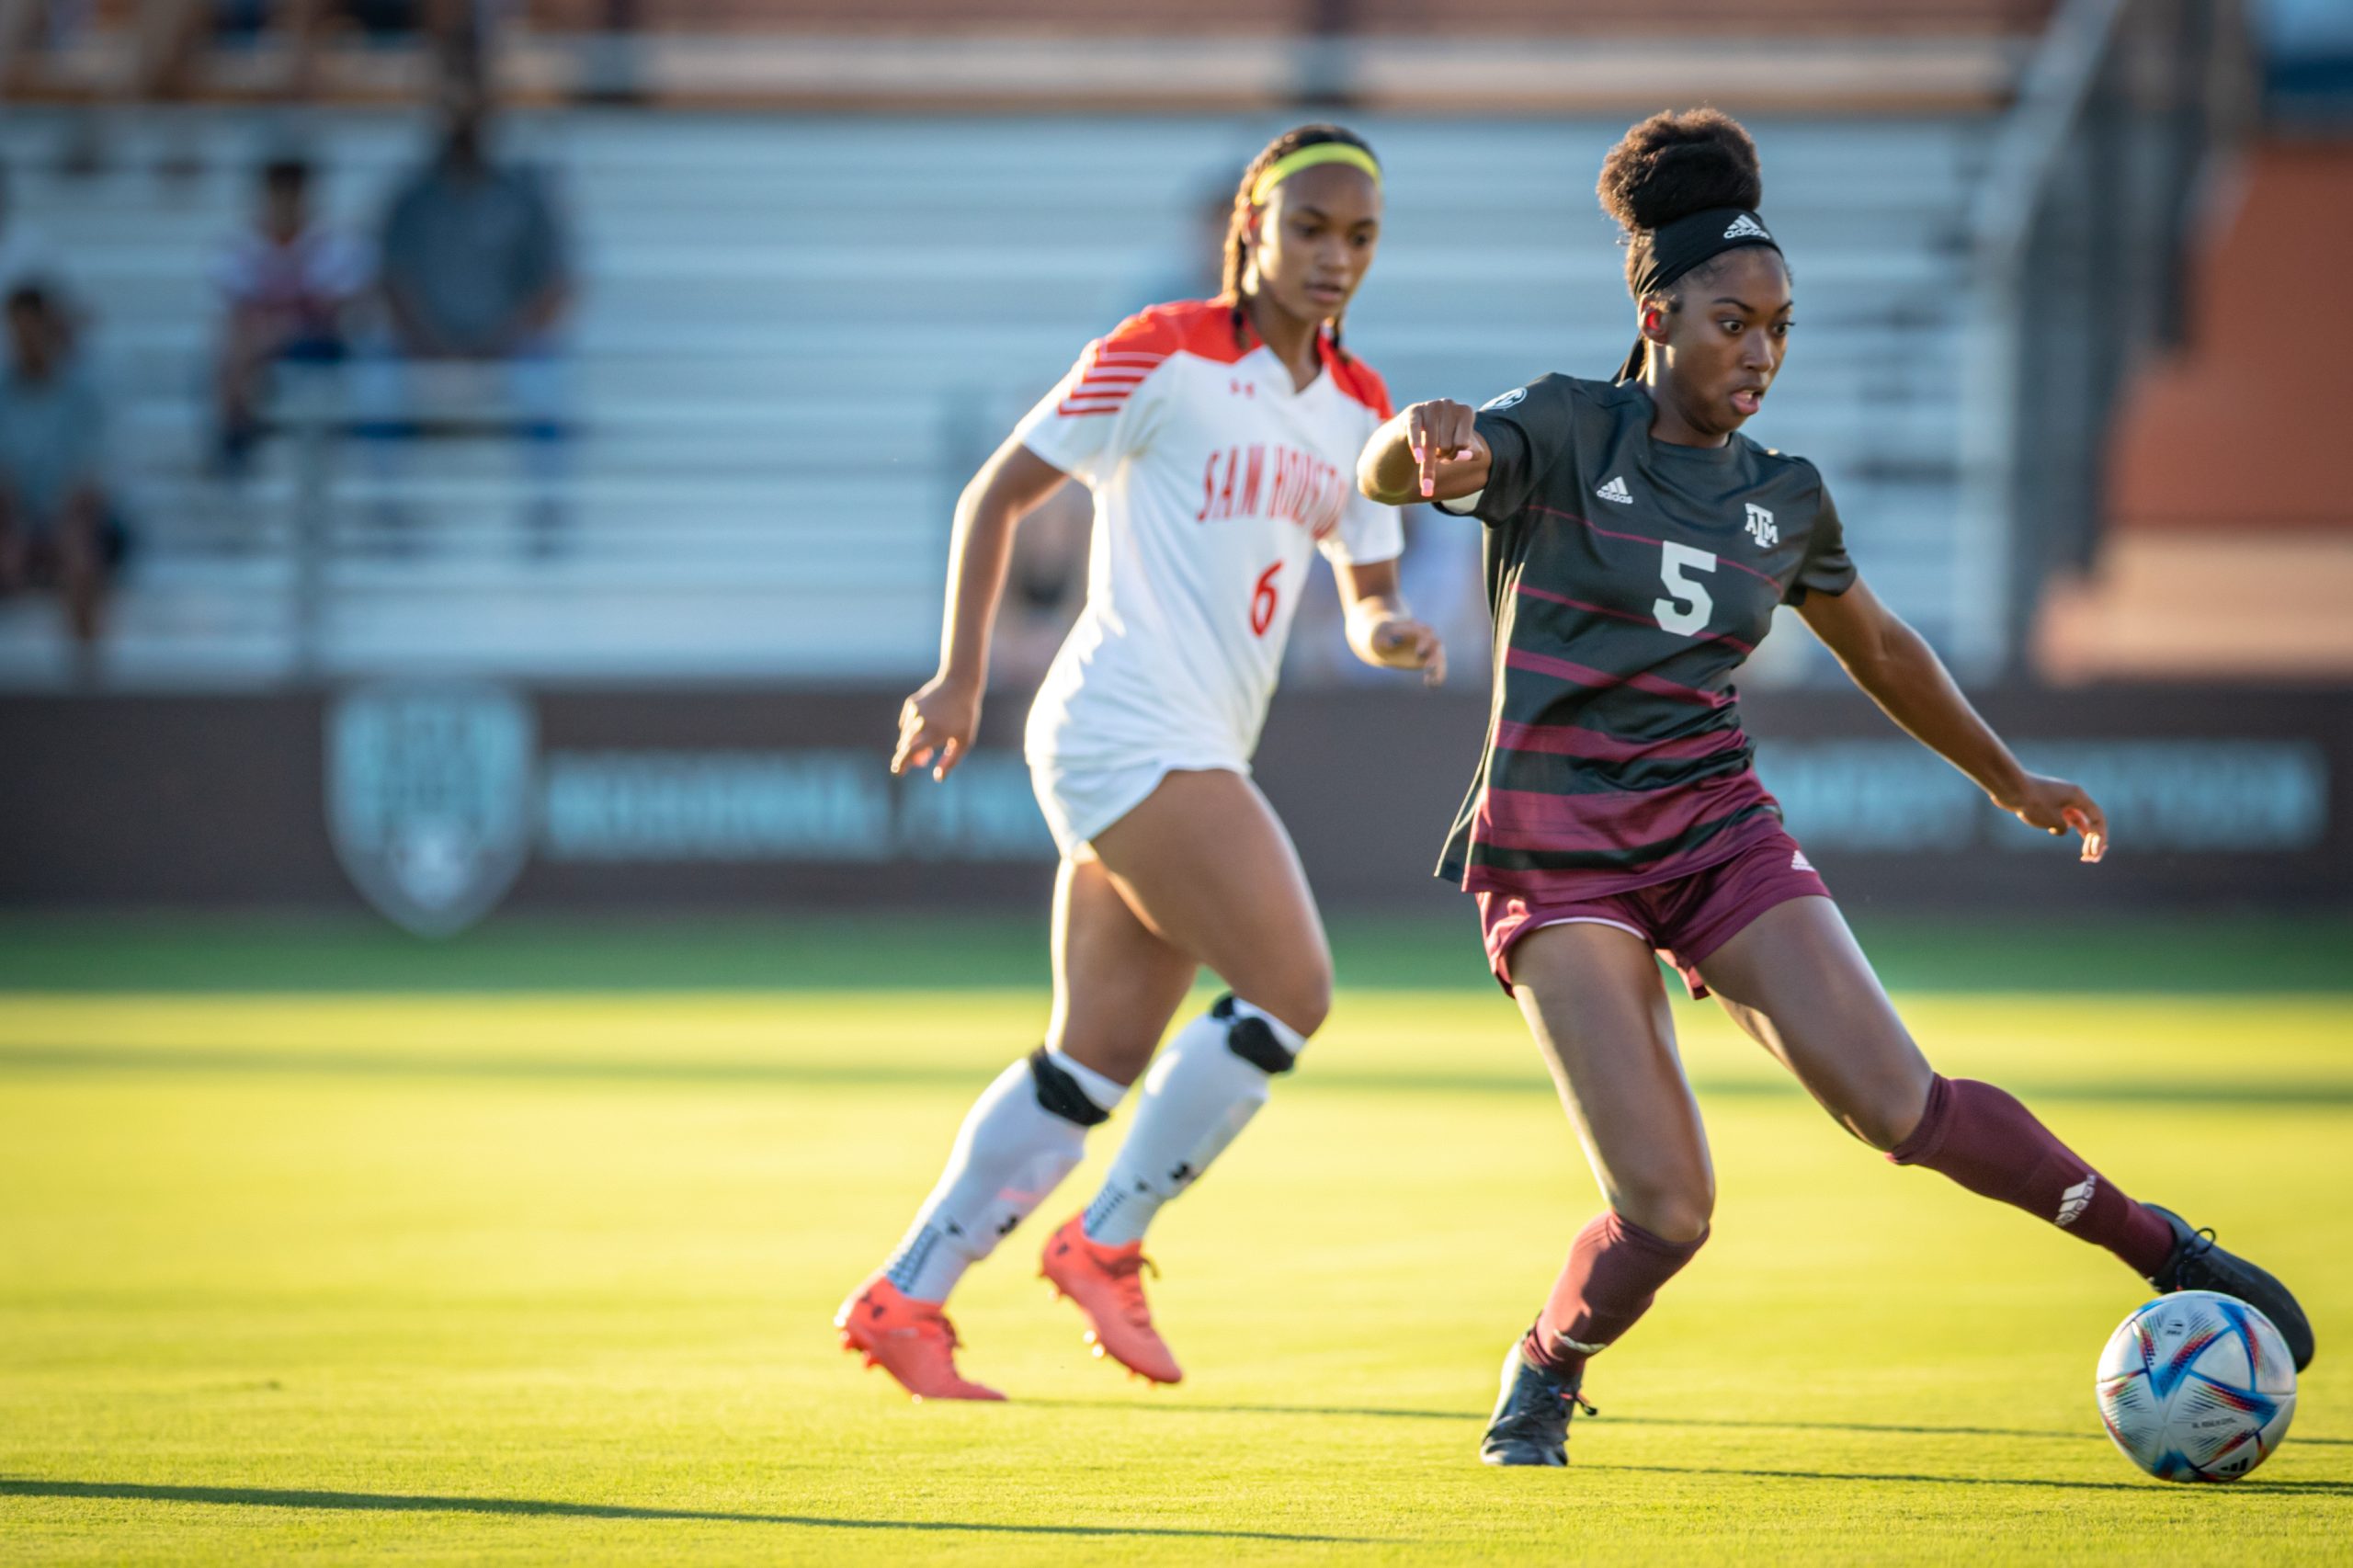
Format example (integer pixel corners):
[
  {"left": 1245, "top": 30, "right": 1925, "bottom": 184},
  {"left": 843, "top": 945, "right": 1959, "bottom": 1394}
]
[{"left": 835, "top": 125, "right": 1445, "bottom": 1399}]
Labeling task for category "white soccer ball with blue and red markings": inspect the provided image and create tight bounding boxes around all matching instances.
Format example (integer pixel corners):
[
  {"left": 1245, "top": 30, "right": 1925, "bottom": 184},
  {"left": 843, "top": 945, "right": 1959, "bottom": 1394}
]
[{"left": 2097, "top": 1290, "right": 2297, "bottom": 1481}]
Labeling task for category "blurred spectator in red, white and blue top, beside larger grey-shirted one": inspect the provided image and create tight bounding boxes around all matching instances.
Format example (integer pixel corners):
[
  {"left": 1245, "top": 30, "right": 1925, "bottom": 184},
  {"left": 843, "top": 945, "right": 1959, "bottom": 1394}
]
[{"left": 214, "top": 158, "right": 369, "bottom": 475}]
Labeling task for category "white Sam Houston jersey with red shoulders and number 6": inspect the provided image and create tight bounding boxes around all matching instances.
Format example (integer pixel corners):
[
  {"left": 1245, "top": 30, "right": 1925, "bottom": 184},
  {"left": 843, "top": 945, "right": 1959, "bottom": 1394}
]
[{"left": 1014, "top": 301, "right": 1404, "bottom": 767}]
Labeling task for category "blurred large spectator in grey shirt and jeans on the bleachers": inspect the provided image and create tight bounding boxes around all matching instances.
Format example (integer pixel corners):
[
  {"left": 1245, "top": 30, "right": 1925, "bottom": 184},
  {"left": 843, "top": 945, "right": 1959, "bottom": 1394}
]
[{"left": 360, "top": 92, "right": 572, "bottom": 544}]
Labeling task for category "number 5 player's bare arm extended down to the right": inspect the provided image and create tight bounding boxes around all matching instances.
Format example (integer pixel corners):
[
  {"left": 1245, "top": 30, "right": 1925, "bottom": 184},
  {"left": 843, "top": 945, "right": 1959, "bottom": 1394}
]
[{"left": 1798, "top": 577, "right": 2109, "bottom": 862}]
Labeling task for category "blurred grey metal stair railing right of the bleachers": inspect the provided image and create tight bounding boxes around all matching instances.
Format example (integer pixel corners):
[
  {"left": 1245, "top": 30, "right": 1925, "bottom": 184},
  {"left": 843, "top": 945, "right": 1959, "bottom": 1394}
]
[{"left": 1953, "top": 0, "right": 2256, "bottom": 680}]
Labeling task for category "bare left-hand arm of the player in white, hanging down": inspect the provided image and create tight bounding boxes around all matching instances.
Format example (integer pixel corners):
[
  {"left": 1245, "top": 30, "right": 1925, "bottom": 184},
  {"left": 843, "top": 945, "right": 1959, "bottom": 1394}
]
[{"left": 890, "top": 437, "right": 1068, "bottom": 779}]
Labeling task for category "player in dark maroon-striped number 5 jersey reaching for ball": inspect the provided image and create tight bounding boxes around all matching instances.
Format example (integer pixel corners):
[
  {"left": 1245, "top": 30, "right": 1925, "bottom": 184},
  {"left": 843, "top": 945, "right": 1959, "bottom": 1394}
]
[{"left": 1358, "top": 110, "right": 2313, "bottom": 1464}]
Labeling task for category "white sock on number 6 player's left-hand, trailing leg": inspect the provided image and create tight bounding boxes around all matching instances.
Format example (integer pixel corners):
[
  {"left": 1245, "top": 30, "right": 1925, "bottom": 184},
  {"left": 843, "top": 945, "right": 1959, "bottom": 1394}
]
[{"left": 882, "top": 1050, "right": 1127, "bottom": 1302}]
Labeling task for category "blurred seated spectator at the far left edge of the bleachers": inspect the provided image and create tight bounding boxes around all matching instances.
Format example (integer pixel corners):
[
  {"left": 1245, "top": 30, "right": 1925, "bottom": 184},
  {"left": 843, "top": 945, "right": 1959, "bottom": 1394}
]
[{"left": 0, "top": 282, "right": 120, "bottom": 650}]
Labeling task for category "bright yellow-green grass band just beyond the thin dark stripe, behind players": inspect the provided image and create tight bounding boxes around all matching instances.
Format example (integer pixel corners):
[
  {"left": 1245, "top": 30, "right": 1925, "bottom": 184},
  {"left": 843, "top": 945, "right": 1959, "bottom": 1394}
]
[{"left": 0, "top": 986, "right": 2353, "bottom": 1092}]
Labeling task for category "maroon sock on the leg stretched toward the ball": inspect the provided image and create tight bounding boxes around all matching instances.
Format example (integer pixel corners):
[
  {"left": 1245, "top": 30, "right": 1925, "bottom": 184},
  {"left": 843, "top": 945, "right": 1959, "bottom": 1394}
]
[{"left": 1887, "top": 1076, "right": 2174, "bottom": 1278}]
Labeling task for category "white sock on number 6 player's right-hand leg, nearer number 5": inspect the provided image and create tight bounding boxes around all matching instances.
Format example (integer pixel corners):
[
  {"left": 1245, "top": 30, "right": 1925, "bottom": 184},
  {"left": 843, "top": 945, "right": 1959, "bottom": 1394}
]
[{"left": 1085, "top": 998, "right": 1306, "bottom": 1245}]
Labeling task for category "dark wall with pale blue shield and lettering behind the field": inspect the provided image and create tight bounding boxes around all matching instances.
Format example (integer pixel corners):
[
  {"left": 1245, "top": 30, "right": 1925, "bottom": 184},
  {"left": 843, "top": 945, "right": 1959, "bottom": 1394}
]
[{"left": 0, "top": 683, "right": 2353, "bottom": 927}]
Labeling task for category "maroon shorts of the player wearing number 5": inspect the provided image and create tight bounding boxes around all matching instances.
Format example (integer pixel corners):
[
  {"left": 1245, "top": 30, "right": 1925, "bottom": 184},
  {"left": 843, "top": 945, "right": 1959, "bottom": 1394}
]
[{"left": 1478, "top": 826, "right": 1831, "bottom": 996}]
